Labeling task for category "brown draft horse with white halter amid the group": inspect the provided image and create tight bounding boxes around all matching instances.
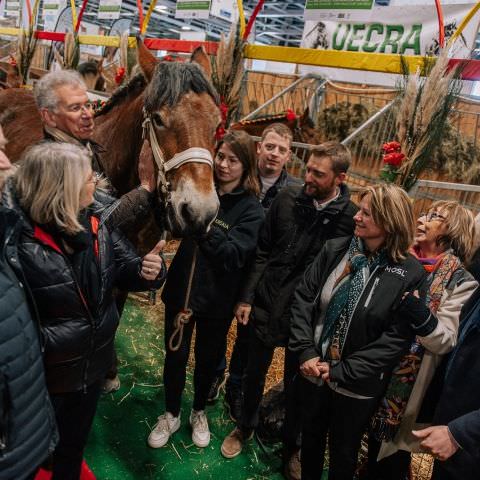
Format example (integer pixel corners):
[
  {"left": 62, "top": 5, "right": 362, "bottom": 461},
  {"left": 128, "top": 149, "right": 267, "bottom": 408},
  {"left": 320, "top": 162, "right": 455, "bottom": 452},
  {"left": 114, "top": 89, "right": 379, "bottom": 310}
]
[{"left": 0, "top": 42, "right": 220, "bottom": 242}]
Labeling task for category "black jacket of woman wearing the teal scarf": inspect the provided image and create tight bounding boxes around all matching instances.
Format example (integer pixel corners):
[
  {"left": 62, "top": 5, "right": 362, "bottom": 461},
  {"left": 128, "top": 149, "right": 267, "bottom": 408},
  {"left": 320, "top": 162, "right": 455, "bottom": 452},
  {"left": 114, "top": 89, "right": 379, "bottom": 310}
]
[{"left": 289, "top": 237, "right": 428, "bottom": 397}]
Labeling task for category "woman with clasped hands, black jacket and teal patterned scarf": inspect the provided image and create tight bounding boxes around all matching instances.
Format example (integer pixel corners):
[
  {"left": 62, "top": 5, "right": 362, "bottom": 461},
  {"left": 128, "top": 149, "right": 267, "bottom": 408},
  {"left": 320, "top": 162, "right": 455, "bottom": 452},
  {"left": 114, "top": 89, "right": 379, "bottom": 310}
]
[{"left": 289, "top": 184, "right": 426, "bottom": 480}]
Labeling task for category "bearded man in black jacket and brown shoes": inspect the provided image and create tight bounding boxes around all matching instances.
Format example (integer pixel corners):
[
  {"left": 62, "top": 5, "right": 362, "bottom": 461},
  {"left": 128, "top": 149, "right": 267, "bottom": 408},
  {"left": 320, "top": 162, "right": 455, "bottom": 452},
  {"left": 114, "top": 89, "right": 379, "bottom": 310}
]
[{"left": 221, "top": 142, "right": 357, "bottom": 477}]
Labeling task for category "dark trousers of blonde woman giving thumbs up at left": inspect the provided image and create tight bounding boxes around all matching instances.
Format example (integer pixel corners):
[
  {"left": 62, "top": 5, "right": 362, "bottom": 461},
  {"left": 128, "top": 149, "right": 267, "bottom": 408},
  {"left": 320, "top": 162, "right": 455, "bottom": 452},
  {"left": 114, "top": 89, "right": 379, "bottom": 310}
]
[{"left": 50, "top": 380, "right": 103, "bottom": 480}]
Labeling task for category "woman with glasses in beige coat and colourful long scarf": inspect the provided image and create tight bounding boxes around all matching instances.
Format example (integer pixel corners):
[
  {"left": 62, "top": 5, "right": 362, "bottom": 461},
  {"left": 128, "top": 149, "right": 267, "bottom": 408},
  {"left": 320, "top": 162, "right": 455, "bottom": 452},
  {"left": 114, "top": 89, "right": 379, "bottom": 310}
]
[{"left": 368, "top": 201, "right": 478, "bottom": 480}]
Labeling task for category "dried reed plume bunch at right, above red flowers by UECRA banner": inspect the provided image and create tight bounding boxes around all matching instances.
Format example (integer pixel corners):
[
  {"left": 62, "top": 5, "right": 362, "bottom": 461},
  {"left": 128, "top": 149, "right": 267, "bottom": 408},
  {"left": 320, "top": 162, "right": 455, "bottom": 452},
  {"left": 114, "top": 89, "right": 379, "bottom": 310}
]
[{"left": 396, "top": 49, "right": 461, "bottom": 191}]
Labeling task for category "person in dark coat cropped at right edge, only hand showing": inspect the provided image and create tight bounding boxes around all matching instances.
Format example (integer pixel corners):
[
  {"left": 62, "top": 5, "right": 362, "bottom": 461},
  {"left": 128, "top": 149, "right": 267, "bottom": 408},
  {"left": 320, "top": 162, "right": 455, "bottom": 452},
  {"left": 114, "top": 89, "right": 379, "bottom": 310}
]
[{"left": 413, "top": 289, "right": 480, "bottom": 480}]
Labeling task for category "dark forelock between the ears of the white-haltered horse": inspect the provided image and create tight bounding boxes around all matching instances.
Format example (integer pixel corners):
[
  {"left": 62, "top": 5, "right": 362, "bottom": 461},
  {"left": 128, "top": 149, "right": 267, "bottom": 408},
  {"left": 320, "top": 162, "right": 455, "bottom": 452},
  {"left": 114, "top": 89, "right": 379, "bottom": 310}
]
[{"left": 145, "top": 62, "right": 219, "bottom": 112}]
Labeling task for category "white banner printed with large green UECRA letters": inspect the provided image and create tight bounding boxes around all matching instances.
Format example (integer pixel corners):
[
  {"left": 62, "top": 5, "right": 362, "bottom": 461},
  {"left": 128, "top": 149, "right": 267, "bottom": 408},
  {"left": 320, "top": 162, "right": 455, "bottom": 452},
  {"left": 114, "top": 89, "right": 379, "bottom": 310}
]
[{"left": 300, "top": 0, "right": 480, "bottom": 85}]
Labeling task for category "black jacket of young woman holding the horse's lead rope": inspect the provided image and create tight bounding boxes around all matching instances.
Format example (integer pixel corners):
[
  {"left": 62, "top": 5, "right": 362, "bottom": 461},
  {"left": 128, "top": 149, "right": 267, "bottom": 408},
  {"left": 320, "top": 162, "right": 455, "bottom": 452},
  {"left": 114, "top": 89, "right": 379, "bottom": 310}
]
[{"left": 162, "top": 188, "right": 264, "bottom": 318}]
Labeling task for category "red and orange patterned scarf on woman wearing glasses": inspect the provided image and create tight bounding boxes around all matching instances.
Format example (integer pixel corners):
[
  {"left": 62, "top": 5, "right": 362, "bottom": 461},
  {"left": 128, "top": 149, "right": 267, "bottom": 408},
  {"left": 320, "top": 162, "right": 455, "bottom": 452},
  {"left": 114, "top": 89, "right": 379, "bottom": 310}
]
[{"left": 371, "top": 251, "right": 462, "bottom": 442}]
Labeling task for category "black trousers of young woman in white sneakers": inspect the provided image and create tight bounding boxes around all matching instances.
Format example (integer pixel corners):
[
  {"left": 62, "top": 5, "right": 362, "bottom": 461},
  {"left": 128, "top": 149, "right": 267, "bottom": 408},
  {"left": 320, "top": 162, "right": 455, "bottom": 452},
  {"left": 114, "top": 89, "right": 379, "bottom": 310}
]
[{"left": 163, "top": 308, "right": 231, "bottom": 417}]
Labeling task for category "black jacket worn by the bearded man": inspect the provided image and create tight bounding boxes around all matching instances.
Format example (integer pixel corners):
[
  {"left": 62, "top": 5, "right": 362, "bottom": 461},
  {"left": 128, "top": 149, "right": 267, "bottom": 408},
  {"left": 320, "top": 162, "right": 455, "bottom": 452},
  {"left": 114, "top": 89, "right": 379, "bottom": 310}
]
[{"left": 239, "top": 185, "right": 357, "bottom": 347}]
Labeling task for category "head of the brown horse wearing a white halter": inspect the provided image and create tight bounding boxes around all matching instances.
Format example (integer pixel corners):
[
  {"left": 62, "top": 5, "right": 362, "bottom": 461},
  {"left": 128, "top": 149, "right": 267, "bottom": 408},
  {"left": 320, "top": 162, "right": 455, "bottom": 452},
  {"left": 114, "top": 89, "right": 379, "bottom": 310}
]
[{"left": 138, "top": 42, "right": 220, "bottom": 235}]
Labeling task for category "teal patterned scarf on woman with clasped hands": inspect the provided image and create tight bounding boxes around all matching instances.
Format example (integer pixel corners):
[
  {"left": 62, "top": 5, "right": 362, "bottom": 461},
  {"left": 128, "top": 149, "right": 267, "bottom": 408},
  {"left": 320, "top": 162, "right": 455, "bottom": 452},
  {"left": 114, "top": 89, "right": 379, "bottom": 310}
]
[{"left": 320, "top": 237, "right": 387, "bottom": 364}]
